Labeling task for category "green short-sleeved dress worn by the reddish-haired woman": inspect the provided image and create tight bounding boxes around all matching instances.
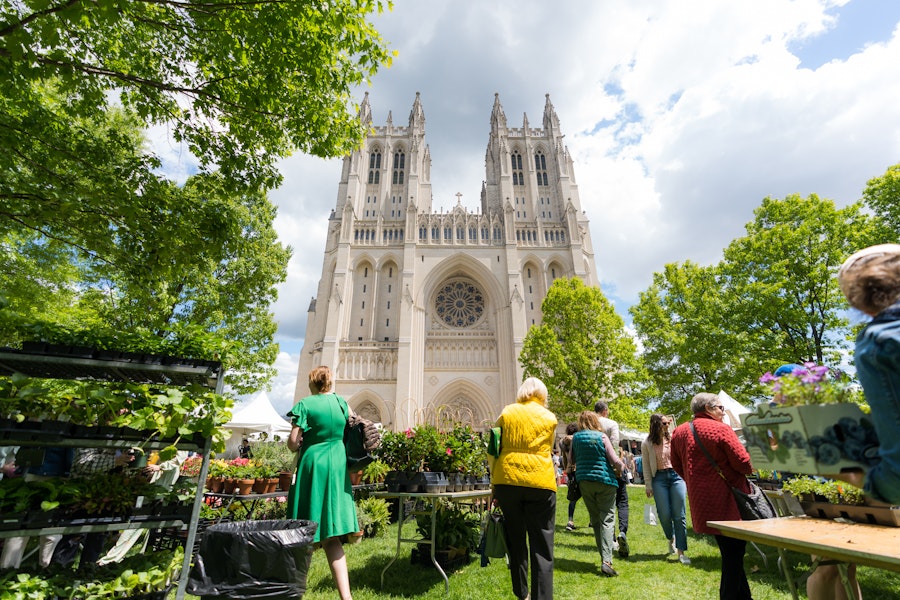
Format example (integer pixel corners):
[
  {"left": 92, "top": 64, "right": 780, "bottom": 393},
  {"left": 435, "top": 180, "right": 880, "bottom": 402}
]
[{"left": 288, "top": 394, "right": 359, "bottom": 542}]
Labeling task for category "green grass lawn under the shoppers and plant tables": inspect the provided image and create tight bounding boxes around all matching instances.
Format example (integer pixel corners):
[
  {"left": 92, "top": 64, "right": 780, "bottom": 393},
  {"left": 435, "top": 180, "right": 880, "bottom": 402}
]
[{"left": 188, "top": 486, "right": 900, "bottom": 600}]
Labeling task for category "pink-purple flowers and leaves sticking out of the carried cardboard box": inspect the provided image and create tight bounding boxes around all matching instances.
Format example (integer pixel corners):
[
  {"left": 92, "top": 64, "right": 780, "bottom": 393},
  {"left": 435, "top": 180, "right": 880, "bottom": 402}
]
[{"left": 759, "top": 362, "right": 859, "bottom": 406}]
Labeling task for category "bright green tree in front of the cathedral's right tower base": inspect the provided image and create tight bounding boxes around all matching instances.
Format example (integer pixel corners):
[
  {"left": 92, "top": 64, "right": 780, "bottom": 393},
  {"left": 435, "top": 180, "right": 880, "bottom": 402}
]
[{"left": 519, "top": 277, "right": 648, "bottom": 427}]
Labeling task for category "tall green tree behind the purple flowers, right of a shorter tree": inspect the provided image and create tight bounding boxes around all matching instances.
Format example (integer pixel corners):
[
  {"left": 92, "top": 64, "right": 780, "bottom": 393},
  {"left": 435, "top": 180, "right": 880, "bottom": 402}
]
[{"left": 722, "top": 194, "right": 873, "bottom": 373}]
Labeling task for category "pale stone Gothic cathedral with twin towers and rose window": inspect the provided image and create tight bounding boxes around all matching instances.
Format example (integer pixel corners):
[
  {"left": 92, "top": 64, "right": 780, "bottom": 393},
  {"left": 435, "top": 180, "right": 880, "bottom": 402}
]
[{"left": 295, "top": 93, "right": 598, "bottom": 430}]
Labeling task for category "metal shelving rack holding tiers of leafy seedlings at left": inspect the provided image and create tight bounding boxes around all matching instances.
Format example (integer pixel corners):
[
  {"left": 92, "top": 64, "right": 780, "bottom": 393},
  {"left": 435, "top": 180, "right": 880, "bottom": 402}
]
[{"left": 0, "top": 348, "right": 225, "bottom": 600}]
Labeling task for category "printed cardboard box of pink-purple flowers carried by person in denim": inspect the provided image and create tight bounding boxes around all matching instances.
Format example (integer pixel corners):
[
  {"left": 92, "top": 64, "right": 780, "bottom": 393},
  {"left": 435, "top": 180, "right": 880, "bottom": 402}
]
[{"left": 741, "top": 363, "right": 878, "bottom": 474}]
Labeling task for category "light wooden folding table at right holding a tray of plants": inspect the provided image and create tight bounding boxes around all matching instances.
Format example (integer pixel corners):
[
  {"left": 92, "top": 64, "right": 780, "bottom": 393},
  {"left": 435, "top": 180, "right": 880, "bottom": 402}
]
[{"left": 709, "top": 517, "right": 900, "bottom": 598}]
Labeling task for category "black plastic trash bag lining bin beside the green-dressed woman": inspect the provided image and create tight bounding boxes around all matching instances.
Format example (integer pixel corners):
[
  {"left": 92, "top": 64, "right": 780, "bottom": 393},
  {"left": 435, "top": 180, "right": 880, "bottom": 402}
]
[{"left": 187, "top": 520, "right": 317, "bottom": 600}]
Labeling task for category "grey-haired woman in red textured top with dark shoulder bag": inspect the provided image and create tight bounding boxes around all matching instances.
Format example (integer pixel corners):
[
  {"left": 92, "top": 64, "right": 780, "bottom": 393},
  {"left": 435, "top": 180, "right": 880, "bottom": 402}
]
[{"left": 672, "top": 392, "right": 753, "bottom": 600}]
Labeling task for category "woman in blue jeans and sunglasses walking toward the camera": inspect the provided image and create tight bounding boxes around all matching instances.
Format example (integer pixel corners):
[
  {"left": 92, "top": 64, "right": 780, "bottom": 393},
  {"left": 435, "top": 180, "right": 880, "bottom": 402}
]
[{"left": 641, "top": 414, "right": 691, "bottom": 565}]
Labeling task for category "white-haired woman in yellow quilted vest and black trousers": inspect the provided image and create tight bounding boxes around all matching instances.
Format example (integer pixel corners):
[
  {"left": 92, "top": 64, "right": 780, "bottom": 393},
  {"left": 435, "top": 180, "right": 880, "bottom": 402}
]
[{"left": 491, "top": 377, "right": 556, "bottom": 600}]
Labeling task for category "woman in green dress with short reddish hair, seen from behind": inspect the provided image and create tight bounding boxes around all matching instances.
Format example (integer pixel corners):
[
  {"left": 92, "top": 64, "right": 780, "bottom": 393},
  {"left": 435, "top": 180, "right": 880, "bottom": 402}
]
[{"left": 288, "top": 366, "right": 359, "bottom": 600}]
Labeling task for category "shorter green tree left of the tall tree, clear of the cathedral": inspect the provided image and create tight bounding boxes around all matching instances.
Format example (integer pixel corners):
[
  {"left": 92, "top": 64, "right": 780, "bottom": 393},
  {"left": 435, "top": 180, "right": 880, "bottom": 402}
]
[{"left": 630, "top": 261, "right": 759, "bottom": 414}]
